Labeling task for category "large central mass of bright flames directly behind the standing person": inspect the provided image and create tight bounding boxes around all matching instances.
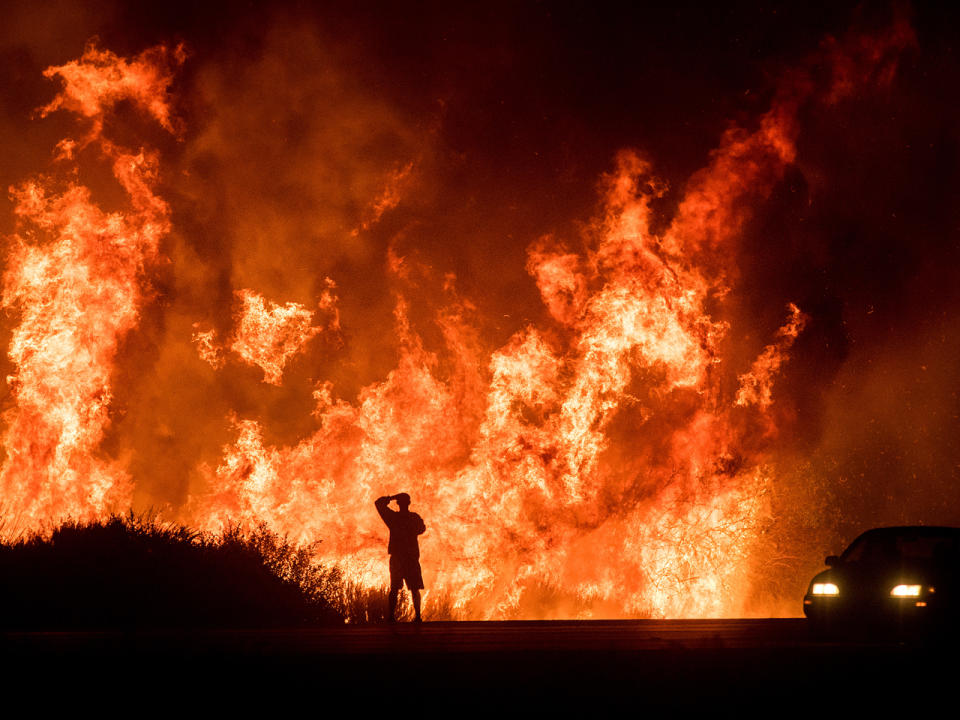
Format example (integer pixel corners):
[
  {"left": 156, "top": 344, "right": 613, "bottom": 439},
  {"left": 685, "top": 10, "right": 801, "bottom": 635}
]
[{"left": 190, "top": 135, "right": 799, "bottom": 617}]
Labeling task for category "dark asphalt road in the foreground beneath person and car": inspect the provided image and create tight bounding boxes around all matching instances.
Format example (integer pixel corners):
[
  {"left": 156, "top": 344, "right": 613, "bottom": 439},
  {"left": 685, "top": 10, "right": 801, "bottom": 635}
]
[{"left": 0, "top": 619, "right": 960, "bottom": 716}]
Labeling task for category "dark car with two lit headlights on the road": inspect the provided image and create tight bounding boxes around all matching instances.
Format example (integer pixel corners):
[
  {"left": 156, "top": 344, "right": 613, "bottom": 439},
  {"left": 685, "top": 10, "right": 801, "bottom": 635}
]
[{"left": 803, "top": 526, "right": 960, "bottom": 632}]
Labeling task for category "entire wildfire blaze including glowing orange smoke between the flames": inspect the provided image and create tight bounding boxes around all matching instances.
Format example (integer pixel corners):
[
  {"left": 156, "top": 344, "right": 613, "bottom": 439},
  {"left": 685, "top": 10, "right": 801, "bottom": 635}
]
[{"left": 0, "top": 4, "right": 956, "bottom": 619}]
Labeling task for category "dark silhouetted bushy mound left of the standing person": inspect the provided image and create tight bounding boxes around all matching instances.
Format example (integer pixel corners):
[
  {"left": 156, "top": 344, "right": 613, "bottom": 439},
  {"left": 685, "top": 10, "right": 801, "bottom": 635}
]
[{"left": 0, "top": 515, "right": 343, "bottom": 630}]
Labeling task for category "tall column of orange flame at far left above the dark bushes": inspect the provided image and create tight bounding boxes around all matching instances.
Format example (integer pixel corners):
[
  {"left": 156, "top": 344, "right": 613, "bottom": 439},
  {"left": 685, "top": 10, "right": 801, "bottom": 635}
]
[{"left": 0, "top": 45, "right": 184, "bottom": 527}]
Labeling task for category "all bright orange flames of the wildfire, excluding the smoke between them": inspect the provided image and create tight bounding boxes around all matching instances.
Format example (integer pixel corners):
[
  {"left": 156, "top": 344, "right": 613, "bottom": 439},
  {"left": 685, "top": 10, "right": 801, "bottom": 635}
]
[{"left": 0, "top": 22, "right": 909, "bottom": 618}]
